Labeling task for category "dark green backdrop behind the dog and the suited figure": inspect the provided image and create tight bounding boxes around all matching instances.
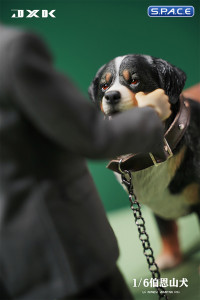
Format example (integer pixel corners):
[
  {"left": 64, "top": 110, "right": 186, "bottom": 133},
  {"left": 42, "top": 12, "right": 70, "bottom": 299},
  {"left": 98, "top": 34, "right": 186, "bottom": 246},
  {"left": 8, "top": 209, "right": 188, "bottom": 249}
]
[{"left": 0, "top": 0, "right": 200, "bottom": 210}]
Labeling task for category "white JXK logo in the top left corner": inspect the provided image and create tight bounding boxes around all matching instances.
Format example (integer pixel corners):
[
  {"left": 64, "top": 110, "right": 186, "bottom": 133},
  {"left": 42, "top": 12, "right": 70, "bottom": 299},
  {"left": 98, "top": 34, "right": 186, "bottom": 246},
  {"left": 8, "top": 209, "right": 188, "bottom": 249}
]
[{"left": 11, "top": 9, "right": 56, "bottom": 19}]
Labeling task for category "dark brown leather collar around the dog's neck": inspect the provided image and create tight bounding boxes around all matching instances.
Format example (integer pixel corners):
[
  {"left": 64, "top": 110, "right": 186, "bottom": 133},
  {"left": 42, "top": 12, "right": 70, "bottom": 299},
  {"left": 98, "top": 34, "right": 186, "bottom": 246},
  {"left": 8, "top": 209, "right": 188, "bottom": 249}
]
[{"left": 107, "top": 95, "right": 190, "bottom": 174}]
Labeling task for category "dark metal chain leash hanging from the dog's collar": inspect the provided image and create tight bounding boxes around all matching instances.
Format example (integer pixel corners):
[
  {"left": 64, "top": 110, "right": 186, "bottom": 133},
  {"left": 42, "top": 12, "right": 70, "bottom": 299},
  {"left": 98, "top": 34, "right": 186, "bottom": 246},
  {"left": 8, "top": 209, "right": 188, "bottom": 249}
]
[{"left": 118, "top": 160, "right": 168, "bottom": 300}]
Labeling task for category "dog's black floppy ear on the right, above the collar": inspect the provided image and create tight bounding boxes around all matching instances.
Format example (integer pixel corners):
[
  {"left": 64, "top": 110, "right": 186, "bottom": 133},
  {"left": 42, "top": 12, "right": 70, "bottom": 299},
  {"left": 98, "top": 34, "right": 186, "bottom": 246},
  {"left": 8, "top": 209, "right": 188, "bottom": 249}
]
[{"left": 155, "top": 58, "right": 186, "bottom": 104}]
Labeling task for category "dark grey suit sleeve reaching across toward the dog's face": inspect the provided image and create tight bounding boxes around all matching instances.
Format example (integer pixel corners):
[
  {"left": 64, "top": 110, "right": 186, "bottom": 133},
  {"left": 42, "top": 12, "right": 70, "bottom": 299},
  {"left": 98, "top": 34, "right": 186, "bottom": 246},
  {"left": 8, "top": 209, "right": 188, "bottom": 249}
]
[{"left": 9, "top": 33, "right": 162, "bottom": 158}]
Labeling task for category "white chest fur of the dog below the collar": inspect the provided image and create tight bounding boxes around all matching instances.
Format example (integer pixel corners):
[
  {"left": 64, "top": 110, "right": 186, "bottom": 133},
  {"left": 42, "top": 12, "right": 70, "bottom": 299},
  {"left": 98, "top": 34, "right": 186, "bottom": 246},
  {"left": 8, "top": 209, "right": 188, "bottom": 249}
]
[{"left": 115, "top": 161, "right": 189, "bottom": 219}]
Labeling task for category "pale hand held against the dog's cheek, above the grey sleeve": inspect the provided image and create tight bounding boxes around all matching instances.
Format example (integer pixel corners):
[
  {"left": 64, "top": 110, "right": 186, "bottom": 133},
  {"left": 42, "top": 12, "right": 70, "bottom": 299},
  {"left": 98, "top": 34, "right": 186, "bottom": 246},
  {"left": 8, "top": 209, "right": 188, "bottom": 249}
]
[{"left": 135, "top": 89, "right": 171, "bottom": 121}]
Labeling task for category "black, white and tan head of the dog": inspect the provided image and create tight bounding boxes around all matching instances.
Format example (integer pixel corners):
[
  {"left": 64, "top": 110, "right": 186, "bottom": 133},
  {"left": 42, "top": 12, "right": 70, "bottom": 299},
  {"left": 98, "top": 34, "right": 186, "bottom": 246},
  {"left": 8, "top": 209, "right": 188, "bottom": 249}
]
[{"left": 89, "top": 54, "right": 186, "bottom": 115}]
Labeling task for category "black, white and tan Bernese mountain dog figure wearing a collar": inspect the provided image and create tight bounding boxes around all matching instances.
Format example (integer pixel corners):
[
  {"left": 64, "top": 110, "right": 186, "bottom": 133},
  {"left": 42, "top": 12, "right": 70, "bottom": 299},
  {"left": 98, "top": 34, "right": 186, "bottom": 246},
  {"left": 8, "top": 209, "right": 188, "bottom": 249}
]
[{"left": 89, "top": 54, "right": 200, "bottom": 269}]
